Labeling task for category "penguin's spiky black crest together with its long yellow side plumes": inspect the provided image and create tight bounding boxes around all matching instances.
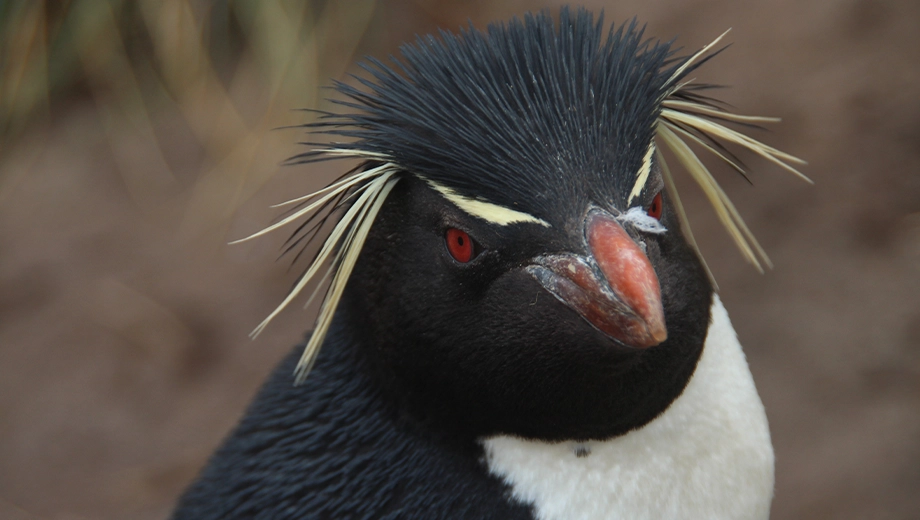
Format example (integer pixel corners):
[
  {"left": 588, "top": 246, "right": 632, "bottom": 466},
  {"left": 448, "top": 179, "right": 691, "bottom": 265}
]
[{"left": 235, "top": 8, "right": 804, "bottom": 380}]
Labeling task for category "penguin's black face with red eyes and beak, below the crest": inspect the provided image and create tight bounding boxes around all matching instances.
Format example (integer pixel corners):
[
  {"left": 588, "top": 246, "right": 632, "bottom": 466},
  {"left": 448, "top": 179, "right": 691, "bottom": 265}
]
[{"left": 346, "top": 172, "right": 712, "bottom": 440}]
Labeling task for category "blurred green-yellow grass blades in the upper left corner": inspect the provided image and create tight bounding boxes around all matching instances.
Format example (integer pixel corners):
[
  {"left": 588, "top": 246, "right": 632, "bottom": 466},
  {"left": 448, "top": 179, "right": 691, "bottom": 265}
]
[{"left": 0, "top": 0, "right": 376, "bottom": 225}]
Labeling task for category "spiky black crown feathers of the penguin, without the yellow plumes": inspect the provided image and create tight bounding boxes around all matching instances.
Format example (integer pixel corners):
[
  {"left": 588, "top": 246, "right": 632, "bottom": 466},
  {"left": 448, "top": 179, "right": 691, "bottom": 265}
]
[{"left": 315, "top": 9, "right": 687, "bottom": 222}]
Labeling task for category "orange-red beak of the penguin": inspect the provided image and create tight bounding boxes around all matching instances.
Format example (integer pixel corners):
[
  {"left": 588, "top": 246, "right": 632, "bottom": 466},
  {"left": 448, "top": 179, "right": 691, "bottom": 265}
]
[{"left": 526, "top": 209, "right": 668, "bottom": 348}]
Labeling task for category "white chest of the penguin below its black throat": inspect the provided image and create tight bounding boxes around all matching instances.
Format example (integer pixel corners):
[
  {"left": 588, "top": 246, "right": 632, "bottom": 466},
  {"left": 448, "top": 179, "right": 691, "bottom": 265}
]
[{"left": 483, "top": 296, "right": 773, "bottom": 520}]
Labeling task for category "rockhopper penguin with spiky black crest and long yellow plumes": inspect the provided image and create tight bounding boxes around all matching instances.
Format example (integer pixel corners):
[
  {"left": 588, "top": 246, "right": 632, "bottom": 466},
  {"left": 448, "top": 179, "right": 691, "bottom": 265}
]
[{"left": 174, "top": 9, "right": 799, "bottom": 520}]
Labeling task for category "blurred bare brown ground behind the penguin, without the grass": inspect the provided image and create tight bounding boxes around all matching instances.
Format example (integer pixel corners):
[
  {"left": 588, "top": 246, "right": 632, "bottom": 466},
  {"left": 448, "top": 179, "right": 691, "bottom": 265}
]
[{"left": 0, "top": 0, "right": 920, "bottom": 519}]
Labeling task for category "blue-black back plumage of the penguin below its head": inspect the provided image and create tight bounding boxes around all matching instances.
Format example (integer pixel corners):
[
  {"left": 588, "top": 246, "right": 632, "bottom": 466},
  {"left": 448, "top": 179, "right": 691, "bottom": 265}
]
[{"left": 173, "top": 328, "right": 531, "bottom": 520}]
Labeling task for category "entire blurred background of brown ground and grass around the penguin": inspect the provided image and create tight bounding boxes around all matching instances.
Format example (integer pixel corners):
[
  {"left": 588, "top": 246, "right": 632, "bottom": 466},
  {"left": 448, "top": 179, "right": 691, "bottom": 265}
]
[{"left": 0, "top": 0, "right": 920, "bottom": 519}]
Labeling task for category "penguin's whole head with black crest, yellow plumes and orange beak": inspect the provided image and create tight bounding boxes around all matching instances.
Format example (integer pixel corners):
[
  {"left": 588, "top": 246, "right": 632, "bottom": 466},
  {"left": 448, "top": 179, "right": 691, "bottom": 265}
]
[{"left": 237, "top": 8, "right": 796, "bottom": 440}]
